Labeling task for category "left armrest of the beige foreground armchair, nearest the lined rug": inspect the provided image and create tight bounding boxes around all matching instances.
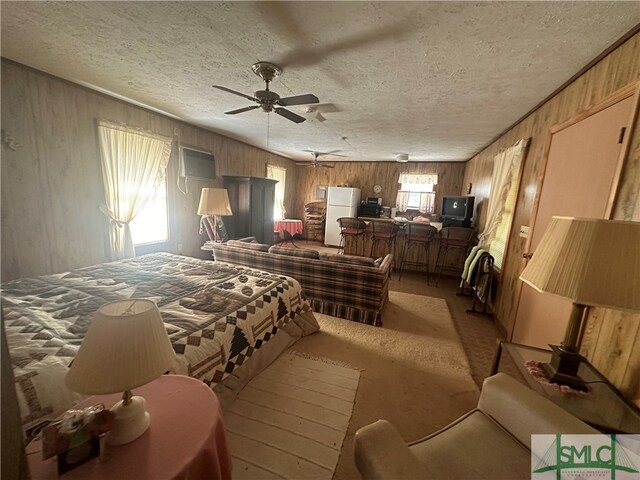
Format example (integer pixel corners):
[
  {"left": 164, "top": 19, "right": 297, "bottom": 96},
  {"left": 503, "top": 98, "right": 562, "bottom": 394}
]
[{"left": 354, "top": 420, "right": 425, "bottom": 480}]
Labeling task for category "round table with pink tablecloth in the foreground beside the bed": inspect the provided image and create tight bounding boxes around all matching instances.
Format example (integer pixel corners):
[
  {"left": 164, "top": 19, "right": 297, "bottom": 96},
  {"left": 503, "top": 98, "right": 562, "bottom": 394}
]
[{"left": 27, "top": 375, "right": 231, "bottom": 480}]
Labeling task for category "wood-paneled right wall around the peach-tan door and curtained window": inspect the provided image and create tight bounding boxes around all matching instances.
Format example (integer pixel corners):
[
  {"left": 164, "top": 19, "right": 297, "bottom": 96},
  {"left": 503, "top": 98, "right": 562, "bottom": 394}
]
[{"left": 464, "top": 34, "right": 640, "bottom": 401}]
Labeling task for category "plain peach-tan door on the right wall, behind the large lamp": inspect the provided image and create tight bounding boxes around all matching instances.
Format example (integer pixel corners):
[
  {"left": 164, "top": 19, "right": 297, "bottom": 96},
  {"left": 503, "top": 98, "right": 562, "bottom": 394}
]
[{"left": 512, "top": 89, "right": 637, "bottom": 347}]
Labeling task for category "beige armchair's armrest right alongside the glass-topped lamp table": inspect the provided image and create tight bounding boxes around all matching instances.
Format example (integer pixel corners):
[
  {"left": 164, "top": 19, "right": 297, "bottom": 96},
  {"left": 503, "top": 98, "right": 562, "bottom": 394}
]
[{"left": 478, "top": 373, "right": 599, "bottom": 449}]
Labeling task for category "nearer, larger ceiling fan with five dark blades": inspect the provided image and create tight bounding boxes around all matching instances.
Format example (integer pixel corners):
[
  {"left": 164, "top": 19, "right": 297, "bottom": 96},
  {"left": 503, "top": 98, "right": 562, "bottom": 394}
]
[{"left": 214, "top": 62, "right": 320, "bottom": 123}]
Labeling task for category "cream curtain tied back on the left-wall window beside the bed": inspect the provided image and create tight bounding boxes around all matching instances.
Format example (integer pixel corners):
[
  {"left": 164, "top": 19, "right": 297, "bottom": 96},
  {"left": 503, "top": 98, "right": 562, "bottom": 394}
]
[{"left": 98, "top": 120, "right": 171, "bottom": 260}]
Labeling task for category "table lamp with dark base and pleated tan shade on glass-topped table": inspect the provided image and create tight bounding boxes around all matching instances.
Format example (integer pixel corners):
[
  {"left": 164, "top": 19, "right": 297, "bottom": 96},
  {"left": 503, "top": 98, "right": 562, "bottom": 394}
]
[{"left": 520, "top": 217, "right": 640, "bottom": 390}]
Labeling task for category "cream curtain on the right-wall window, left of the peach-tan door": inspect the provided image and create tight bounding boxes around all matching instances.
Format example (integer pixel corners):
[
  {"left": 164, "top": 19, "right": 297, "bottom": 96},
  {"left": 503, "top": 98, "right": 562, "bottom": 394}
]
[{"left": 478, "top": 138, "right": 529, "bottom": 246}]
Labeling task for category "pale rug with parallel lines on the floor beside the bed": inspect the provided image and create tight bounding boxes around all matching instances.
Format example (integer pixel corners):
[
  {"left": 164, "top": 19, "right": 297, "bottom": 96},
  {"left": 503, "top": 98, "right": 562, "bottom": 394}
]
[{"left": 224, "top": 352, "right": 360, "bottom": 479}]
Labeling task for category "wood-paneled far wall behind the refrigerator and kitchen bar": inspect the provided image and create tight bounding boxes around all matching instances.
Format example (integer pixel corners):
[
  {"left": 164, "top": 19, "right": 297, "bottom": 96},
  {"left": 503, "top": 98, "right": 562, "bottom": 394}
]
[{"left": 294, "top": 162, "right": 465, "bottom": 219}]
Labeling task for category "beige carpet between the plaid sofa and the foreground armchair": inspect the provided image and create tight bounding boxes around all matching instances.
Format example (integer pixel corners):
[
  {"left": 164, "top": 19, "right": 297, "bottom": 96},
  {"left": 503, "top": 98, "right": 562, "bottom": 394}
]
[{"left": 292, "top": 292, "right": 479, "bottom": 480}]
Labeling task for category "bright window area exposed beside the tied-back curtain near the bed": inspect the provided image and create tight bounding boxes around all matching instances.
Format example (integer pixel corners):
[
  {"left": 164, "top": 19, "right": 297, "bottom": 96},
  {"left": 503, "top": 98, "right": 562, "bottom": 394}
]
[{"left": 129, "top": 175, "right": 169, "bottom": 245}]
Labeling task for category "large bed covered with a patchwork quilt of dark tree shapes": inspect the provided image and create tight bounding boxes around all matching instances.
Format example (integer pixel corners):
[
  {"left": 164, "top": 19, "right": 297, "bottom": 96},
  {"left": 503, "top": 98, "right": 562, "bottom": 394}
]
[{"left": 2, "top": 253, "right": 318, "bottom": 438}]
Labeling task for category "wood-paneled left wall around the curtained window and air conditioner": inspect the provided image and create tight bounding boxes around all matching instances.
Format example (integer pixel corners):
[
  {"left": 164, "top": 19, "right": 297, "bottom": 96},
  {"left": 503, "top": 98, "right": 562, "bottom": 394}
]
[{"left": 1, "top": 59, "right": 298, "bottom": 281}]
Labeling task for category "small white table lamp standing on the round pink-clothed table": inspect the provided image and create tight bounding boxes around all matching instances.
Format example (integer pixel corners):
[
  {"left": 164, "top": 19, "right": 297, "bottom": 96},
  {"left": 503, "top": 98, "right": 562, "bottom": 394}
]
[{"left": 65, "top": 299, "right": 175, "bottom": 445}]
